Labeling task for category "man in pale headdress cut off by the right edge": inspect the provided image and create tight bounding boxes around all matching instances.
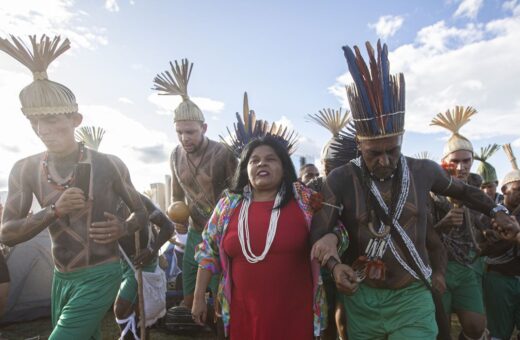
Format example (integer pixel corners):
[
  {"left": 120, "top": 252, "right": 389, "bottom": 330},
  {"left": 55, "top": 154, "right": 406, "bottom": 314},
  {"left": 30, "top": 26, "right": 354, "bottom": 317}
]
[{"left": 482, "top": 144, "right": 520, "bottom": 340}]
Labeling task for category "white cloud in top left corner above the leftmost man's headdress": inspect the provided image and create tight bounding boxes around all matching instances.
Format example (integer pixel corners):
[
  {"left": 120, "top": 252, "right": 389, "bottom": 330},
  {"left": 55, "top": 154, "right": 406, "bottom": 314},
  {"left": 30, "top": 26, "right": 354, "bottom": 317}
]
[{"left": 0, "top": 0, "right": 108, "bottom": 49}]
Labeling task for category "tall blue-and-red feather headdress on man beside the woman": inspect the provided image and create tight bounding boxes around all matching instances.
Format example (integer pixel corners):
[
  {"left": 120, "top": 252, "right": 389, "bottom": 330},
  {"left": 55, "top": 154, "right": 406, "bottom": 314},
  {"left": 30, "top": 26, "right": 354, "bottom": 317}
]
[{"left": 343, "top": 41, "right": 405, "bottom": 140}]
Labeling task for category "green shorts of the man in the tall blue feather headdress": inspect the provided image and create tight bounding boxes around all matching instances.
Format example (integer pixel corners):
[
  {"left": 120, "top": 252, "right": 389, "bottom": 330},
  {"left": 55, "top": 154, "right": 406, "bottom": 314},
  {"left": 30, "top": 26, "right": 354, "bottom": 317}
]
[{"left": 344, "top": 282, "right": 437, "bottom": 340}]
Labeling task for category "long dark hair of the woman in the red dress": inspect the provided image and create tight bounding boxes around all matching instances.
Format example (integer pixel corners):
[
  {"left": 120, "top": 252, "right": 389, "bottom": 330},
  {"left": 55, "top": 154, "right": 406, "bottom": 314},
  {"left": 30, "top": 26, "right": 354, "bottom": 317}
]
[{"left": 230, "top": 136, "right": 297, "bottom": 209}]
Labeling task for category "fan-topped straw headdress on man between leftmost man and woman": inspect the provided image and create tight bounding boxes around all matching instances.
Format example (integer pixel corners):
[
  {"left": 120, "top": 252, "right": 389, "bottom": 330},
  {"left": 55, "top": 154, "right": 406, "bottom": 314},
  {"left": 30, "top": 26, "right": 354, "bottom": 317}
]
[{"left": 152, "top": 59, "right": 204, "bottom": 122}]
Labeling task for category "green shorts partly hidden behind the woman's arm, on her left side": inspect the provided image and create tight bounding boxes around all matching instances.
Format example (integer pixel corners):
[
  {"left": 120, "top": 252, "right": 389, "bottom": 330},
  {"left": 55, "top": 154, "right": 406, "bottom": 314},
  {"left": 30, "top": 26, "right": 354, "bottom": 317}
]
[{"left": 182, "top": 227, "right": 218, "bottom": 296}]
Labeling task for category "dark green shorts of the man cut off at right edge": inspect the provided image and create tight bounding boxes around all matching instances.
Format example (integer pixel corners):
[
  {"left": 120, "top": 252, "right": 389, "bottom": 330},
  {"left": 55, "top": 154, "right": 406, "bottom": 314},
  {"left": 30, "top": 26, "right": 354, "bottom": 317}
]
[{"left": 482, "top": 272, "right": 520, "bottom": 339}]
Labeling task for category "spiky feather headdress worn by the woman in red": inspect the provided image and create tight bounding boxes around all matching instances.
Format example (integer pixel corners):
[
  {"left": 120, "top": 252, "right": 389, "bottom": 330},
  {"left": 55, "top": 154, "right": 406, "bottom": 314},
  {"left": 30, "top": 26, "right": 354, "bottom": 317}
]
[{"left": 220, "top": 92, "right": 298, "bottom": 158}]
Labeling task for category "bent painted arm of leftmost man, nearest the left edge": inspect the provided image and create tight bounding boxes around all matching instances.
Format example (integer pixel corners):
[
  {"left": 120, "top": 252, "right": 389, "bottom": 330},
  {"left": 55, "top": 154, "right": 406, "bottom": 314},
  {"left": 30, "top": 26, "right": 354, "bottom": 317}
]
[{"left": 0, "top": 160, "right": 56, "bottom": 247}]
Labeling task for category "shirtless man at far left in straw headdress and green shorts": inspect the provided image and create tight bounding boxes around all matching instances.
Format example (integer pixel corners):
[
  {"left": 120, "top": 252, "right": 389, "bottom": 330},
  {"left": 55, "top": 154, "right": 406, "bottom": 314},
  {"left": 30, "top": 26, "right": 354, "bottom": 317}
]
[{"left": 0, "top": 36, "right": 148, "bottom": 339}]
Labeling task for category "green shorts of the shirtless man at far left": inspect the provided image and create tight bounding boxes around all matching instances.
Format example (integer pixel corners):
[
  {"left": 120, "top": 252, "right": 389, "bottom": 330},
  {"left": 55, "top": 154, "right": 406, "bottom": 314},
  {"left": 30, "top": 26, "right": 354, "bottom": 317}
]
[{"left": 49, "top": 262, "right": 121, "bottom": 340}]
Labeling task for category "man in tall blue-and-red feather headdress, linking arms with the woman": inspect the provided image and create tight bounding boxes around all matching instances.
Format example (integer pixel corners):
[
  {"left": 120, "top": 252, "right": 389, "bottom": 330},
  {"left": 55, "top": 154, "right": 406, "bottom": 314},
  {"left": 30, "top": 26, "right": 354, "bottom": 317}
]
[{"left": 311, "top": 43, "right": 519, "bottom": 339}]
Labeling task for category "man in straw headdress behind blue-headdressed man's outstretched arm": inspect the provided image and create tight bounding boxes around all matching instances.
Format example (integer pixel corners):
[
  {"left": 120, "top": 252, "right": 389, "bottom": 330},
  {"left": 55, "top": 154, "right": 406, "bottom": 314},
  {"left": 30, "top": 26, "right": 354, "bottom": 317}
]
[{"left": 432, "top": 106, "right": 492, "bottom": 339}]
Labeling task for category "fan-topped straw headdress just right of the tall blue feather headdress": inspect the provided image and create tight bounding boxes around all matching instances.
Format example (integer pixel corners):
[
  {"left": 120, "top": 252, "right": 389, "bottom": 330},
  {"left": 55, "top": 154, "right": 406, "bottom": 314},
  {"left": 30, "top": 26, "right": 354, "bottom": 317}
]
[{"left": 430, "top": 106, "right": 477, "bottom": 158}]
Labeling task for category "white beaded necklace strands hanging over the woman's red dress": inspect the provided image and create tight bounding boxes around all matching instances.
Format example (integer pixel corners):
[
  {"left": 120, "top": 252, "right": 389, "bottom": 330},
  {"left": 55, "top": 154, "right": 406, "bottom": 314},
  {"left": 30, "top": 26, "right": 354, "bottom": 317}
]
[{"left": 238, "top": 188, "right": 284, "bottom": 263}]
